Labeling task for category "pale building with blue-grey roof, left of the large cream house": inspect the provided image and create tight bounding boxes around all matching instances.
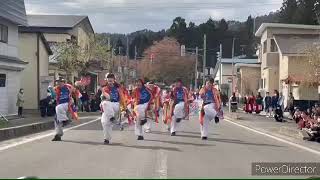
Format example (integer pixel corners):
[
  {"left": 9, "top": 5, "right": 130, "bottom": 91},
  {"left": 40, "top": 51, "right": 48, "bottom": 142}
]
[{"left": 215, "top": 58, "right": 258, "bottom": 97}]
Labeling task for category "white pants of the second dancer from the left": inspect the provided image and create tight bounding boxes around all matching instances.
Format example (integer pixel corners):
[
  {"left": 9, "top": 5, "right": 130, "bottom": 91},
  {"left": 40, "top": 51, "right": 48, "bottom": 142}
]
[{"left": 101, "top": 101, "right": 120, "bottom": 141}]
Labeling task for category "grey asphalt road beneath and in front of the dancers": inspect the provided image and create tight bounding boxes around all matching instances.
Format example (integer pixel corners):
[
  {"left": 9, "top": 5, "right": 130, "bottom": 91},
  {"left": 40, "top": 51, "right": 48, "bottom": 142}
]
[{"left": 0, "top": 115, "right": 320, "bottom": 178}]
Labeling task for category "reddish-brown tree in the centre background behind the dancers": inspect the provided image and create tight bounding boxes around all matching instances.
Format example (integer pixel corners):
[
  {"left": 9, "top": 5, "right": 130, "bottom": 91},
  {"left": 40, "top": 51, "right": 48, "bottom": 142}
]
[{"left": 139, "top": 38, "right": 195, "bottom": 84}]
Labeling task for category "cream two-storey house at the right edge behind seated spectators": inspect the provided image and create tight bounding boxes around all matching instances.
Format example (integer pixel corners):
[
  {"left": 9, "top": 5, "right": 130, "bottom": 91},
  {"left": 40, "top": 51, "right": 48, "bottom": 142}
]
[{"left": 255, "top": 23, "right": 320, "bottom": 106}]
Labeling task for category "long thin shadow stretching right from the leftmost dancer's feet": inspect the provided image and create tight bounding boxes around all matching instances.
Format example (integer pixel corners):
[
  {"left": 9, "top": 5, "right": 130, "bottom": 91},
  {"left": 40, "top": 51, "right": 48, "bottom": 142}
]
[{"left": 63, "top": 140, "right": 181, "bottom": 152}]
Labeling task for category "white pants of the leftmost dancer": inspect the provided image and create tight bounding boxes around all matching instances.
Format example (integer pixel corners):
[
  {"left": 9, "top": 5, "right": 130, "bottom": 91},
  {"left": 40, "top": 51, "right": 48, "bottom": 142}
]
[{"left": 54, "top": 103, "right": 69, "bottom": 136}]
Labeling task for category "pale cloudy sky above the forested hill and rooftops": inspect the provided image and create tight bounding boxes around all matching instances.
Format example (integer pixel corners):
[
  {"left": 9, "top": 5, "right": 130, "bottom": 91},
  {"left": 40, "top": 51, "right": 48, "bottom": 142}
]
[{"left": 25, "top": 0, "right": 282, "bottom": 33}]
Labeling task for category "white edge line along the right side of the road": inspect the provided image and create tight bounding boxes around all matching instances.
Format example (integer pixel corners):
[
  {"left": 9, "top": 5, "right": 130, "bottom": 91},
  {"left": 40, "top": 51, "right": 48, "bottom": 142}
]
[{"left": 224, "top": 119, "right": 320, "bottom": 156}]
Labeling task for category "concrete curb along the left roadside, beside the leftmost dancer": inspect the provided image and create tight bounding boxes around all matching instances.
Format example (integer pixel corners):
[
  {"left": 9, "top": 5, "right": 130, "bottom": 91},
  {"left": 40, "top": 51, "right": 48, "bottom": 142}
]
[{"left": 0, "top": 121, "right": 54, "bottom": 141}]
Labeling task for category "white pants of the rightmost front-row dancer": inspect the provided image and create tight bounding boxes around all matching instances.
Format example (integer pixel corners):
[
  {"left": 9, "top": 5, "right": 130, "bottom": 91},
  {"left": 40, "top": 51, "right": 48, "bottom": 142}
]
[{"left": 200, "top": 103, "right": 217, "bottom": 137}]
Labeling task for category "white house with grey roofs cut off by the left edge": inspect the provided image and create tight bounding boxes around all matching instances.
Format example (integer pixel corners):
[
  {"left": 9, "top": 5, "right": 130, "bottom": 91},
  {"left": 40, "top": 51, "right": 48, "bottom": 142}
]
[{"left": 0, "top": 0, "right": 27, "bottom": 116}]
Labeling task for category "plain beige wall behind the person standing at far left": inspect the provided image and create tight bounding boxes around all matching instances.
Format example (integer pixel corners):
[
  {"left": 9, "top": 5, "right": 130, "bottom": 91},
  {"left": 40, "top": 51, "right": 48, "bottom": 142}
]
[{"left": 19, "top": 33, "right": 38, "bottom": 109}]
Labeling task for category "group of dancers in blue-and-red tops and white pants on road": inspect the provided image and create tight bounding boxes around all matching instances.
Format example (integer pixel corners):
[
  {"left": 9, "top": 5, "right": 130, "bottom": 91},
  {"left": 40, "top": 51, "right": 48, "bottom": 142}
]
[{"left": 52, "top": 73, "right": 222, "bottom": 144}]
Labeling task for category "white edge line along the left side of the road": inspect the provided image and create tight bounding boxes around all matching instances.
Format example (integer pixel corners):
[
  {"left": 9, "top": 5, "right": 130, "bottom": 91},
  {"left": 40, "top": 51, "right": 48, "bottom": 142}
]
[{"left": 0, "top": 117, "right": 100, "bottom": 151}]
